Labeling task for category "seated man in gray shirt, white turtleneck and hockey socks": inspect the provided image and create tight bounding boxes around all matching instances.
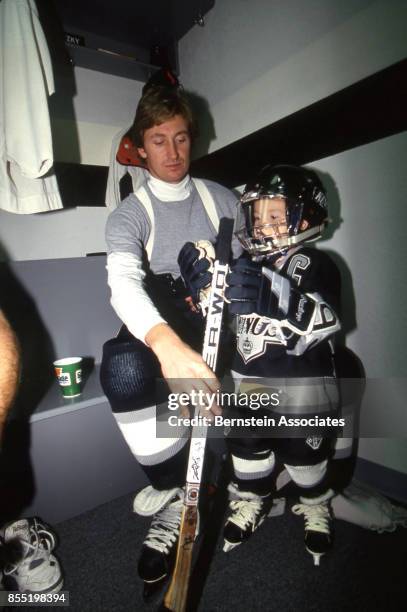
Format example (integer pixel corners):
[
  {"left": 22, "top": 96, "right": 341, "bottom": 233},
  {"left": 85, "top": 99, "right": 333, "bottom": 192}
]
[{"left": 101, "top": 73, "right": 236, "bottom": 583}]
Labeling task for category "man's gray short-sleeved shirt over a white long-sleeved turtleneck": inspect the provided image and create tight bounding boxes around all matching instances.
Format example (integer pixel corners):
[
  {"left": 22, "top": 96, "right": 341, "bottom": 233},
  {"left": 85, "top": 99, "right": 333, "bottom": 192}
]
[{"left": 106, "top": 175, "right": 239, "bottom": 342}]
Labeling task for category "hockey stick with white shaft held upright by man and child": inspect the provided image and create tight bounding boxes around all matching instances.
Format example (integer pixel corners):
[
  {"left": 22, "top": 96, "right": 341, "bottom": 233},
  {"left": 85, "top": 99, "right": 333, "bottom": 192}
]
[{"left": 164, "top": 218, "right": 233, "bottom": 612}]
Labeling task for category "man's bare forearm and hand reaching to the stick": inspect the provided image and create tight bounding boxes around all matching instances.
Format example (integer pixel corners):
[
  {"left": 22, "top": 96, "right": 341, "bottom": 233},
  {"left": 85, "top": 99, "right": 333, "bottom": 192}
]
[{"left": 146, "top": 323, "right": 222, "bottom": 418}]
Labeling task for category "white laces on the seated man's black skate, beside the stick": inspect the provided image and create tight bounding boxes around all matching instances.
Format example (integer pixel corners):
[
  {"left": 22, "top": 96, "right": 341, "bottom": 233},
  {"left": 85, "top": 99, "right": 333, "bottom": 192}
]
[{"left": 144, "top": 499, "right": 183, "bottom": 553}]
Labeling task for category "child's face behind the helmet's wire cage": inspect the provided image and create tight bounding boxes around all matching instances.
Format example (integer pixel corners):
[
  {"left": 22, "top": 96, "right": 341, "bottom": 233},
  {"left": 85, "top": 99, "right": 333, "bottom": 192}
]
[{"left": 253, "top": 197, "right": 288, "bottom": 238}]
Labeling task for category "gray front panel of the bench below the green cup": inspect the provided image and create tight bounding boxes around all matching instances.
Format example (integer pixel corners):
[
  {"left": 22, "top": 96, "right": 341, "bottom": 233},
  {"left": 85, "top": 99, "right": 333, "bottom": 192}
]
[{"left": 24, "top": 402, "right": 148, "bottom": 524}]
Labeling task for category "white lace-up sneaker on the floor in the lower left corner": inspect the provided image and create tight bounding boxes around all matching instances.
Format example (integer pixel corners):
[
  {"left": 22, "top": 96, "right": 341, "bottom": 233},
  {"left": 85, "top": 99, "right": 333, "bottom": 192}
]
[{"left": 3, "top": 518, "right": 63, "bottom": 593}]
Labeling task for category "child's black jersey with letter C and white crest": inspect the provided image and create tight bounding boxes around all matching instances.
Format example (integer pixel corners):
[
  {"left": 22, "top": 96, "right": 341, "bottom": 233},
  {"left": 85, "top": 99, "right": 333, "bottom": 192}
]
[{"left": 232, "top": 247, "right": 341, "bottom": 378}]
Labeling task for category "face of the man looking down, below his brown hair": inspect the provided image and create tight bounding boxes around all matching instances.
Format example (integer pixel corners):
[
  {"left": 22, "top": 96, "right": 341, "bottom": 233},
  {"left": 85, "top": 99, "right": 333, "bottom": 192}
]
[{"left": 138, "top": 115, "right": 191, "bottom": 183}]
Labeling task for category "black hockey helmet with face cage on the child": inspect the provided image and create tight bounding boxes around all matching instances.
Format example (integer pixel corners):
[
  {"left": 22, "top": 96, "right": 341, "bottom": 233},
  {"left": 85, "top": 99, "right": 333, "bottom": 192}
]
[{"left": 236, "top": 165, "right": 328, "bottom": 259}]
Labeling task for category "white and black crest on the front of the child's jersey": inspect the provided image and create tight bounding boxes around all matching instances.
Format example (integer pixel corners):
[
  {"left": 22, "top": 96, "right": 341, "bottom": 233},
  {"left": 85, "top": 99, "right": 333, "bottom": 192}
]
[{"left": 237, "top": 315, "right": 285, "bottom": 363}]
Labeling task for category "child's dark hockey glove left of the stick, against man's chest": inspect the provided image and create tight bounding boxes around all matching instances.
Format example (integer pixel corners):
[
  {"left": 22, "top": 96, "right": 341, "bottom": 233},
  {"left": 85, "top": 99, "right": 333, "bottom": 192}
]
[{"left": 178, "top": 241, "right": 213, "bottom": 304}]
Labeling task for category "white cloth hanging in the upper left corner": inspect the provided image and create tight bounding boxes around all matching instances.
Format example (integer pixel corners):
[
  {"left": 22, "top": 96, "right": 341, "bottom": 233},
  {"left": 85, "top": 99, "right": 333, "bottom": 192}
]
[{"left": 0, "top": 0, "right": 62, "bottom": 214}]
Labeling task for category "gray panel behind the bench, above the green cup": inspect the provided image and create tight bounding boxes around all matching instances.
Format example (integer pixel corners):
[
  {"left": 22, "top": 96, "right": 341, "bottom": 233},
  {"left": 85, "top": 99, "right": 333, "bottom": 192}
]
[{"left": 1, "top": 256, "right": 120, "bottom": 363}]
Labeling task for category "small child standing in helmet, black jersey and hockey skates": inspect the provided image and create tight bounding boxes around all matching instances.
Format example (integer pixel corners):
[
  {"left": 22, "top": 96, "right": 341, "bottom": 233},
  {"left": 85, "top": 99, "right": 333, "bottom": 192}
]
[{"left": 181, "top": 165, "right": 340, "bottom": 564}]
